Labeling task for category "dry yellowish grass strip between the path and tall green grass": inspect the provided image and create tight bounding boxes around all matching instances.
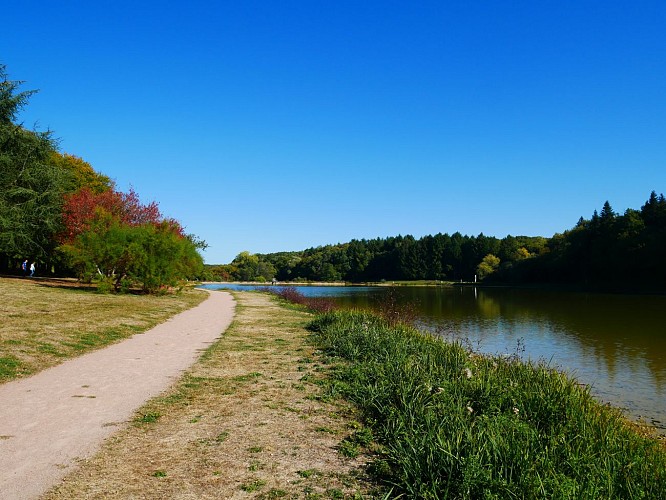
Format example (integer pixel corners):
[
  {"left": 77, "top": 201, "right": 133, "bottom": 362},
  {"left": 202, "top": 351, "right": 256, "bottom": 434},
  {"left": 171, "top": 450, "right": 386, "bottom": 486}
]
[{"left": 46, "top": 292, "right": 369, "bottom": 499}]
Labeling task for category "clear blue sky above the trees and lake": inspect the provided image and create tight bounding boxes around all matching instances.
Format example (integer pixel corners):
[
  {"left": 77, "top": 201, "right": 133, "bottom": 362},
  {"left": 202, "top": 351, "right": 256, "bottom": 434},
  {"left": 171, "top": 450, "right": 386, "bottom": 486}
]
[{"left": 0, "top": 0, "right": 666, "bottom": 263}]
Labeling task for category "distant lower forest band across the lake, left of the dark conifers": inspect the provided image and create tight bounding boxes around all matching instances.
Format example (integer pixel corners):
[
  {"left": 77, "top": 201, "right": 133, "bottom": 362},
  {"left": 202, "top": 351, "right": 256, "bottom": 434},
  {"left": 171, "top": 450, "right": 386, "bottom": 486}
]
[{"left": 215, "top": 233, "right": 547, "bottom": 282}]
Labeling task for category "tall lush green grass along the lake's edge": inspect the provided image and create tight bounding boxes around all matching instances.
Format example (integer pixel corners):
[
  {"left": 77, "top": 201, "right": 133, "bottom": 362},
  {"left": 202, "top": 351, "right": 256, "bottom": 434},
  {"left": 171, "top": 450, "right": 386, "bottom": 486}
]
[{"left": 311, "top": 312, "right": 666, "bottom": 499}]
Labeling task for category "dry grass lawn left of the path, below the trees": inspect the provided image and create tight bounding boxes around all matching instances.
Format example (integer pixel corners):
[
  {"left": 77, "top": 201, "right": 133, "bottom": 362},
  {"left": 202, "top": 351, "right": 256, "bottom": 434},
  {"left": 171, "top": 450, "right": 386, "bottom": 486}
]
[{"left": 0, "top": 278, "right": 207, "bottom": 382}]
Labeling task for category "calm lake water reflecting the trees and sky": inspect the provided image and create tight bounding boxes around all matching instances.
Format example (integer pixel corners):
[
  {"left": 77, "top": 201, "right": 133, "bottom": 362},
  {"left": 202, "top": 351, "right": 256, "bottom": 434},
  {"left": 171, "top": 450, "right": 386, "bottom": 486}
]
[{"left": 200, "top": 284, "right": 666, "bottom": 432}]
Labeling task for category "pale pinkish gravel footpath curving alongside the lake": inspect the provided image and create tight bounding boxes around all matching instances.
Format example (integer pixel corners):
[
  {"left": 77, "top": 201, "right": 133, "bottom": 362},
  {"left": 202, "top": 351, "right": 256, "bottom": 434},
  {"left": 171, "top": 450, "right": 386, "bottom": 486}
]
[{"left": 0, "top": 291, "right": 235, "bottom": 499}]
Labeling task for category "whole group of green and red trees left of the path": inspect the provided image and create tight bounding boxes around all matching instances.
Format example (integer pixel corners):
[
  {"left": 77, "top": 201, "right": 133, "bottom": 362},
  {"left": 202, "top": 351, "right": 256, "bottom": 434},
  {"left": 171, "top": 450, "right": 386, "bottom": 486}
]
[{"left": 0, "top": 65, "right": 205, "bottom": 292}]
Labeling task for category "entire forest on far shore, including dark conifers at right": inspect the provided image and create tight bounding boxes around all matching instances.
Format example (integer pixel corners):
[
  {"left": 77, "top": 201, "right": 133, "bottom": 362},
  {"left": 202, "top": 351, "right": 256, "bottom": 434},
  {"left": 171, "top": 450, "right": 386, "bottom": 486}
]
[{"left": 205, "top": 191, "right": 666, "bottom": 290}]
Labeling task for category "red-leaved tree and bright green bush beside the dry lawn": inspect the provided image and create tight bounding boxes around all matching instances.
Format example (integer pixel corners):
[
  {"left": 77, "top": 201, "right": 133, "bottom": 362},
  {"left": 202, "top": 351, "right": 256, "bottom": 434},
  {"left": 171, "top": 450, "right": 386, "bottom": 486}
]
[{"left": 54, "top": 152, "right": 205, "bottom": 292}]
